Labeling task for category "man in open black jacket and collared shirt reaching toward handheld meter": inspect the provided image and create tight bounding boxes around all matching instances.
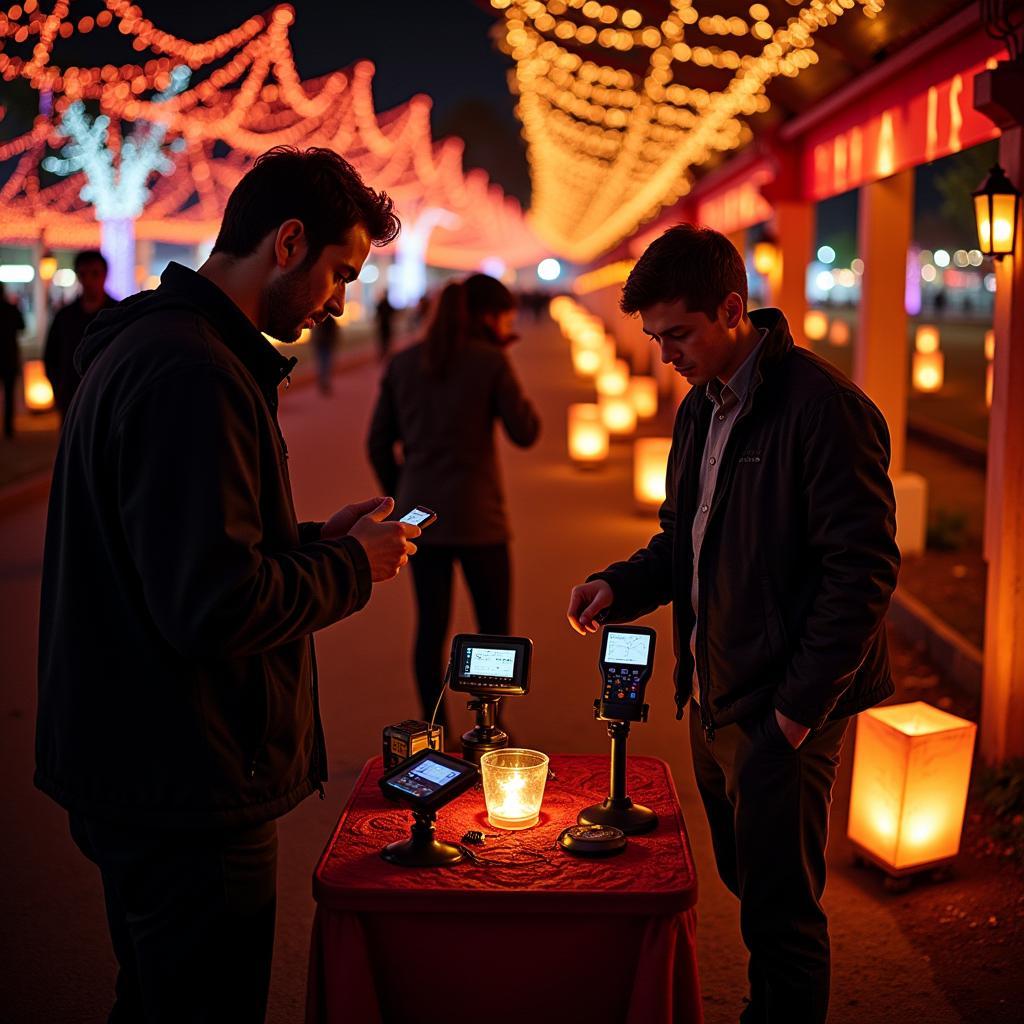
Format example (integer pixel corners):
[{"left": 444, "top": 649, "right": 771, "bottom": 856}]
[{"left": 568, "top": 225, "right": 899, "bottom": 1024}]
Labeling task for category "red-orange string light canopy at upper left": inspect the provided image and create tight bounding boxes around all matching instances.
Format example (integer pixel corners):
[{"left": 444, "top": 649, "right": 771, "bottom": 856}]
[{"left": 0, "top": 0, "right": 547, "bottom": 269}]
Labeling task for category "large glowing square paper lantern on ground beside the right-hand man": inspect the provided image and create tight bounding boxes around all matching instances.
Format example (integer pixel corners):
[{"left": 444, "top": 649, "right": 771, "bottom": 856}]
[{"left": 848, "top": 700, "right": 978, "bottom": 874}]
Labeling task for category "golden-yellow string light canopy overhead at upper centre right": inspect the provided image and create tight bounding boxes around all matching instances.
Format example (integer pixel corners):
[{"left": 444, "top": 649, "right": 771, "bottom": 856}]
[{"left": 489, "top": 0, "right": 885, "bottom": 263}]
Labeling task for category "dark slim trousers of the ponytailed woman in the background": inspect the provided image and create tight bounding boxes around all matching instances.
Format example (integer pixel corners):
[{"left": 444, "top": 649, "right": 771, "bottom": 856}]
[{"left": 410, "top": 544, "right": 512, "bottom": 735}]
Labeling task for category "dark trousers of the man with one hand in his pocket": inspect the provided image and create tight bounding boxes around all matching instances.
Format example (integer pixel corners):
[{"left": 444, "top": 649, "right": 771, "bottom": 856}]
[{"left": 690, "top": 701, "right": 849, "bottom": 1024}]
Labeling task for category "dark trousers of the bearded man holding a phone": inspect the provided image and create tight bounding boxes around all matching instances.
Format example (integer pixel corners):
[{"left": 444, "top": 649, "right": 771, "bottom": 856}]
[{"left": 71, "top": 814, "right": 278, "bottom": 1024}]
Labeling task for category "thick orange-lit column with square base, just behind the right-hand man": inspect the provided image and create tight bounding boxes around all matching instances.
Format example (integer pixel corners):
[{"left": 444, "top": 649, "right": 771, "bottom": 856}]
[{"left": 853, "top": 176, "right": 928, "bottom": 555}]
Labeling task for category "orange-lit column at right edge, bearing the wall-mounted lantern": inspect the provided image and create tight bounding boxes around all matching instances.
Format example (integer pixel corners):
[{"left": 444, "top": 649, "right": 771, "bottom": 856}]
[{"left": 980, "top": 125, "right": 1024, "bottom": 763}]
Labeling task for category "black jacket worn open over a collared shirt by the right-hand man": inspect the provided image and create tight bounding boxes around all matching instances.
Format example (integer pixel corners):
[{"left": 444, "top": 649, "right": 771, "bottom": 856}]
[{"left": 591, "top": 309, "right": 899, "bottom": 734}]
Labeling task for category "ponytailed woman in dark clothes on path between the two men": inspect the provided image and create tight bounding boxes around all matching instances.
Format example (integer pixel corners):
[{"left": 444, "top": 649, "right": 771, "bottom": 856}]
[{"left": 368, "top": 273, "right": 541, "bottom": 724}]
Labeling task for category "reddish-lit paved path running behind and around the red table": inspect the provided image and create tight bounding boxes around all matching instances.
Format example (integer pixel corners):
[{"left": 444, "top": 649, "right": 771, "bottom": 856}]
[{"left": 0, "top": 317, "right": 959, "bottom": 1024}]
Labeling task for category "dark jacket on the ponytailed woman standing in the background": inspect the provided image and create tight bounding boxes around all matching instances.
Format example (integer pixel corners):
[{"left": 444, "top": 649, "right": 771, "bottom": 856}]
[{"left": 367, "top": 339, "right": 541, "bottom": 546}]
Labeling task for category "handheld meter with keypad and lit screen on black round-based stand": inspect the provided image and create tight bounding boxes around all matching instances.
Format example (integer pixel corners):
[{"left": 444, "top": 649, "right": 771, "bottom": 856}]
[{"left": 577, "top": 626, "right": 657, "bottom": 836}]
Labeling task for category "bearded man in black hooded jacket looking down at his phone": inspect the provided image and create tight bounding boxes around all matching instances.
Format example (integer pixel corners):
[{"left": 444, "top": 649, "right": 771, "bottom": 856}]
[{"left": 36, "top": 147, "right": 419, "bottom": 1024}]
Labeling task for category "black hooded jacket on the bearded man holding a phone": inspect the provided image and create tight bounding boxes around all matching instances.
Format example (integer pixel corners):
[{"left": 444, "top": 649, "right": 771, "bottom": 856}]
[{"left": 36, "top": 263, "right": 371, "bottom": 826}]
